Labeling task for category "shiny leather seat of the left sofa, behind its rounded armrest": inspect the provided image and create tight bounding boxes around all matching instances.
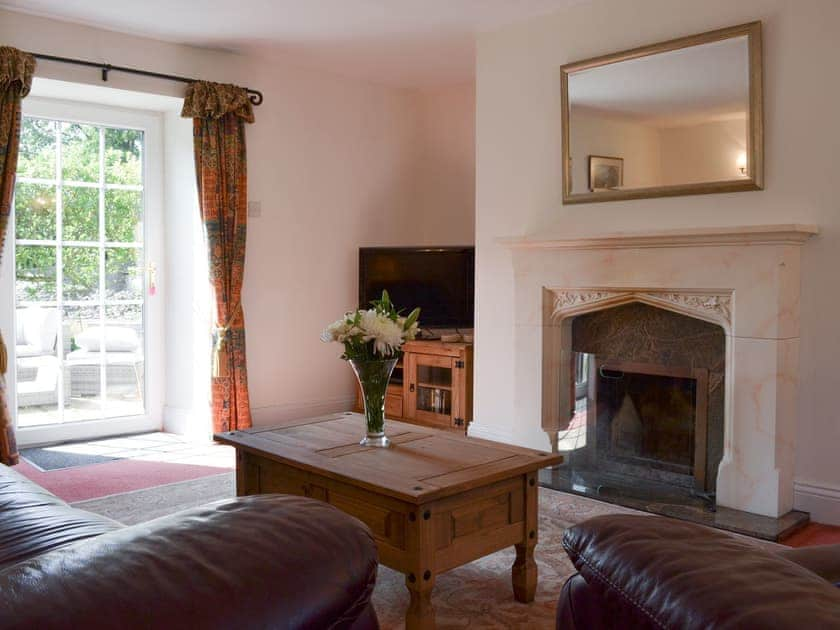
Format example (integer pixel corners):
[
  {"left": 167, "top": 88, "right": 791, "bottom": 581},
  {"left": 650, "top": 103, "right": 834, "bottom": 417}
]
[{"left": 0, "top": 465, "right": 122, "bottom": 570}]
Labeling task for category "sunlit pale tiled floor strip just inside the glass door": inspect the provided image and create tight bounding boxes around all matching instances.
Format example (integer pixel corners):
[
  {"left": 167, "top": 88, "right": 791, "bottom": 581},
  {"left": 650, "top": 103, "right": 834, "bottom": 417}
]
[{"left": 41, "top": 432, "right": 236, "bottom": 468}]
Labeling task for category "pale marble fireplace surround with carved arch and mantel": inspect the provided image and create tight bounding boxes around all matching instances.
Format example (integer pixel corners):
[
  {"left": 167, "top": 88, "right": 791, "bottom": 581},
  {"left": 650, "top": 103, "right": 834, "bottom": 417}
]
[{"left": 501, "top": 225, "right": 818, "bottom": 517}]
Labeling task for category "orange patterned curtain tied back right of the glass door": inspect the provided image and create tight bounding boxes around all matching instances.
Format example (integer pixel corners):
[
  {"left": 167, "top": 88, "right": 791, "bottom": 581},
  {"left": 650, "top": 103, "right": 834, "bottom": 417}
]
[{"left": 181, "top": 81, "right": 254, "bottom": 432}]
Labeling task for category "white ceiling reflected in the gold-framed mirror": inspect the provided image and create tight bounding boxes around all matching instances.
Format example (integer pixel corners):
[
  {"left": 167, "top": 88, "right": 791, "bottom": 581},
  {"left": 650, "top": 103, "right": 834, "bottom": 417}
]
[{"left": 569, "top": 37, "right": 749, "bottom": 126}]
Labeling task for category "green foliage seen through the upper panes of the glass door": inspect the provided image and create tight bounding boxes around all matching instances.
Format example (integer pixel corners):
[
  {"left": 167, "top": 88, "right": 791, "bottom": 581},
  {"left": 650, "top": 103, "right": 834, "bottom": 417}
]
[{"left": 15, "top": 117, "right": 143, "bottom": 308}]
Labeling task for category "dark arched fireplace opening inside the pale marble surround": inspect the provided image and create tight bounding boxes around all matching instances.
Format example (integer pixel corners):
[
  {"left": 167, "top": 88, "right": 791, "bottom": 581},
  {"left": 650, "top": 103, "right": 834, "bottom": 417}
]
[{"left": 554, "top": 303, "right": 726, "bottom": 509}]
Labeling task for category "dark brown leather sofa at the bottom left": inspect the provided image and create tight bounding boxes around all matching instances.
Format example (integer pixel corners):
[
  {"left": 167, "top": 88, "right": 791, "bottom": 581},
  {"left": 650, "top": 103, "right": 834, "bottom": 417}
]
[{"left": 0, "top": 466, "right": 378, "bottom": 630}]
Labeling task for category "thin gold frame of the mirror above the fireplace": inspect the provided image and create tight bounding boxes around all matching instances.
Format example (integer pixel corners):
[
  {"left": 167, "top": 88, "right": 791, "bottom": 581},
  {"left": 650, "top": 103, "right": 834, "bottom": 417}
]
[{"left": 560, "top": 22, "right": 764, "bottom": 204}]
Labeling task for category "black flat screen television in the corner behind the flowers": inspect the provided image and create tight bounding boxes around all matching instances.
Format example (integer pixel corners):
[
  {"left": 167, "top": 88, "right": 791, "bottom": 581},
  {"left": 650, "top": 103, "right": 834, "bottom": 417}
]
[{"left": 359, "top": 247, "right": 475, "bottom": 328}]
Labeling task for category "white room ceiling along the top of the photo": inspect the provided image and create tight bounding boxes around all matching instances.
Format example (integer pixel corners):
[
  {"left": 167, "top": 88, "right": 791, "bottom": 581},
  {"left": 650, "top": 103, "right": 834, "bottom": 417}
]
[{"left": 0, "top": 0, "right": 588, "bottom": 88}]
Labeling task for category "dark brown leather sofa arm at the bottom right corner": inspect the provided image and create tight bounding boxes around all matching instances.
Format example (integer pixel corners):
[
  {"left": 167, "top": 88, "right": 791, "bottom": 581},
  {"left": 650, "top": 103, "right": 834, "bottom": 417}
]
[{"left": 557, "top": 515, "right": 840, "bottom": 630}]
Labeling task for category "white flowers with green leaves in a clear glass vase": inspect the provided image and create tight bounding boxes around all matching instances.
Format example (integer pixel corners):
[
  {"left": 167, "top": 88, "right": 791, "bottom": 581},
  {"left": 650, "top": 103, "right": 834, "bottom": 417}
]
[{"left": 321, "top": 291, "right": 420, "bottom": 447}]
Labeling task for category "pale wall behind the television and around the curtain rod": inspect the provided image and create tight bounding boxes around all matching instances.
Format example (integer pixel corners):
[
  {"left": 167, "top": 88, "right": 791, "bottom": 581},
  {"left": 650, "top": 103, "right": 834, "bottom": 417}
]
[{"left": 0, "top": 10, "right": 473, "bottom": 434}]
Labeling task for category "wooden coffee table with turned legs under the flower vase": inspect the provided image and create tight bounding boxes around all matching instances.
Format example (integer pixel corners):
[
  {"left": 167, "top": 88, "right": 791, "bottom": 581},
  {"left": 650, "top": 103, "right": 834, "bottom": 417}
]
[{"left": 216, "top": 413, "right": 563, "bottom": 630}]
